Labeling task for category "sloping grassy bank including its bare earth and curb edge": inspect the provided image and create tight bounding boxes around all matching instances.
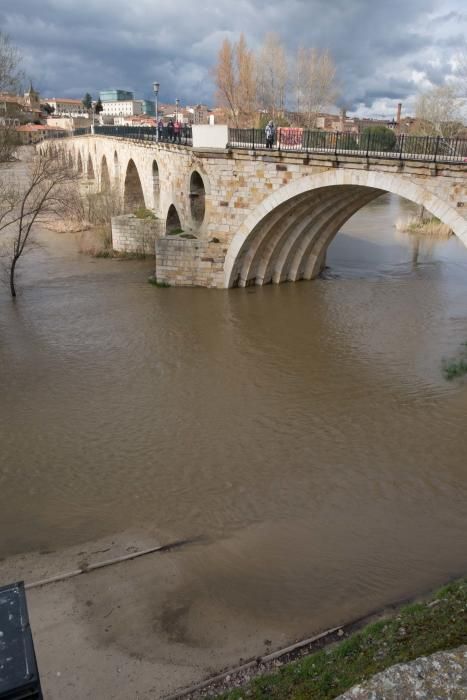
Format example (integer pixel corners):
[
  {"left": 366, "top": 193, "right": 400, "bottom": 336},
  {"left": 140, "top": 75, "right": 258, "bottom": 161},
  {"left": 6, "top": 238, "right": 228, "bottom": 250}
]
[{"left": 172, "top": 579, "right": 467, "bottom": 700}]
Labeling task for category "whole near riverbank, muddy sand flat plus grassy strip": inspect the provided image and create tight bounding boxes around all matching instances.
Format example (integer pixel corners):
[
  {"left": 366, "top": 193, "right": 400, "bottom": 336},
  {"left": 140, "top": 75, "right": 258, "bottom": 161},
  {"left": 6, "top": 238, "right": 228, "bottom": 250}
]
[{"left": 0, "top": 528, "right": 467, "bottom": 700}]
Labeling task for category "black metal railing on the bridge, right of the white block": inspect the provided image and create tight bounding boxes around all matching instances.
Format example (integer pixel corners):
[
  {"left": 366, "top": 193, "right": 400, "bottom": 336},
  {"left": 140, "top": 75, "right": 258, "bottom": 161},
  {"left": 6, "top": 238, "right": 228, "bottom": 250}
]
[{"left": 228, "top": 128, "right": 467, "bottom": 165}]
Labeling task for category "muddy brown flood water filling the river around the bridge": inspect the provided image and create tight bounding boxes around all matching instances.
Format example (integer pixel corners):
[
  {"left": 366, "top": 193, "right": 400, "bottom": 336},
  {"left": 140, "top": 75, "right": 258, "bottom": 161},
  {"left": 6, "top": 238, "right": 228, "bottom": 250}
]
[{"left": 0, "top": 195, "right": 467, "bottom": 637}]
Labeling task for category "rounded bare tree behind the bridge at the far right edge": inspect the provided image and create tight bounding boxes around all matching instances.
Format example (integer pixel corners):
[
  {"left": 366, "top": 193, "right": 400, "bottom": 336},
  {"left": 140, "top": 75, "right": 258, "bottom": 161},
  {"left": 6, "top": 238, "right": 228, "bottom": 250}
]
[{"left": 413, "top": 83, "right": 463, "bottom": 139}]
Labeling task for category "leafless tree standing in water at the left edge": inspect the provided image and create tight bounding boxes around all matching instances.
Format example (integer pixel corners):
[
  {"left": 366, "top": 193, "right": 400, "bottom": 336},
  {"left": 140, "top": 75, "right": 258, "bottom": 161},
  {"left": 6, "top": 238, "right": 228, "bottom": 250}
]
[{"left": 0, "top": 148, "right": 78, "bottom": 297}]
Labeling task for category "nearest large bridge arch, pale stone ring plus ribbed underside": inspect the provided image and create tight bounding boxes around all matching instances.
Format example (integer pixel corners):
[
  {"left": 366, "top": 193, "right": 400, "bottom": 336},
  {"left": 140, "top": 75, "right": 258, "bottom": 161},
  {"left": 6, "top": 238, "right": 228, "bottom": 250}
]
[{"left": 224, "top": 169, "right": 467, "bottom": 287}]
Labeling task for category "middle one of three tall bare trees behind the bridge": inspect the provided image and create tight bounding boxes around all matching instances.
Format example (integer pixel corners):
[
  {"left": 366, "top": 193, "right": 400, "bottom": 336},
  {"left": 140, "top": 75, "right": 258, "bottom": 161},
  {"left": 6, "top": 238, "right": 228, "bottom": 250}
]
[{"left": 257, "top": 32, "right": 288, "bottom": 119}]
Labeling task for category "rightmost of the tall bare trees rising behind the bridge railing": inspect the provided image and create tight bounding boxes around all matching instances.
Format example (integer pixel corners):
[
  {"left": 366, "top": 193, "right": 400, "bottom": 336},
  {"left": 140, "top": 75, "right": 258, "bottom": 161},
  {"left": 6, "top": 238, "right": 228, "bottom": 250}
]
[{"left": 294, "top": 47, "right": 338, "bottom": 128}]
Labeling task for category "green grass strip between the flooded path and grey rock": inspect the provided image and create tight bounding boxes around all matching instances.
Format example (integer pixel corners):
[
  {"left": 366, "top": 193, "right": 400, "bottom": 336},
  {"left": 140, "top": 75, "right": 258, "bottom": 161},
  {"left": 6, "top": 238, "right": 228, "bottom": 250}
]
[{"left": 217, "top": 579, "right": 467, "bottom": 700}]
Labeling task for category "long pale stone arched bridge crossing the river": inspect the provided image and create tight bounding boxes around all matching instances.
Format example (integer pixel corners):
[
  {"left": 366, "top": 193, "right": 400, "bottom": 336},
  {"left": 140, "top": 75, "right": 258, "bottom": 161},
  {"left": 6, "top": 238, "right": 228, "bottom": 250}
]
[{"left": 49, "top": 135, "right": 467, "bottom": 288}]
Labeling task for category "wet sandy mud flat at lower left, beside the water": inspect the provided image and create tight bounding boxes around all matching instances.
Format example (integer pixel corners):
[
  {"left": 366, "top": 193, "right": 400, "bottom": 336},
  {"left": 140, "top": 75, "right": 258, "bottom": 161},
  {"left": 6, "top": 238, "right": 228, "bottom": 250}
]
[{"left": 0, "top": 531, "right": 296, "bottom": 700}]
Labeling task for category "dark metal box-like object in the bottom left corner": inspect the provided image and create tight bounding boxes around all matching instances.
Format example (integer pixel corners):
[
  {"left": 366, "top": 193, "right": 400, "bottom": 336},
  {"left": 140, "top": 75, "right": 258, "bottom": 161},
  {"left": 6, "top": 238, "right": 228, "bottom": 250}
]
[{"left": 0, "top": 582, "right": 43, "bottom": 700}]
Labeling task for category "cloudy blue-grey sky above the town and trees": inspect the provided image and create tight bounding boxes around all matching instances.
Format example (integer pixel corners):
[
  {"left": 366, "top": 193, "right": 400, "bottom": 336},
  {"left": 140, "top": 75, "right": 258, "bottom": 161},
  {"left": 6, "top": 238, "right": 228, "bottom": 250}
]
[{"left": 0, "top": 0, "right": 467, "bottom": 116}]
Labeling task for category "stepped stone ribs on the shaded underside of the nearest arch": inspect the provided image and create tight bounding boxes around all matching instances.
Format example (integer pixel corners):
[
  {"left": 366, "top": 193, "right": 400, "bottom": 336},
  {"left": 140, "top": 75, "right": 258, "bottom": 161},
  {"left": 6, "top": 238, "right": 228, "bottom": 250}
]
[{"left": 231, "top": 185, "right": 384, "bottom": 287}]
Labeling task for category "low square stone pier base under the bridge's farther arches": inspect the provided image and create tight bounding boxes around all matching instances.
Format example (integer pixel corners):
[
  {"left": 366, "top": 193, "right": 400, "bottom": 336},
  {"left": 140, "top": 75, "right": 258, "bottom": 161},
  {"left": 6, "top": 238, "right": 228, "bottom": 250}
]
[{"left": 112, "top": 214, "right": 165, "bottom": 255}]
